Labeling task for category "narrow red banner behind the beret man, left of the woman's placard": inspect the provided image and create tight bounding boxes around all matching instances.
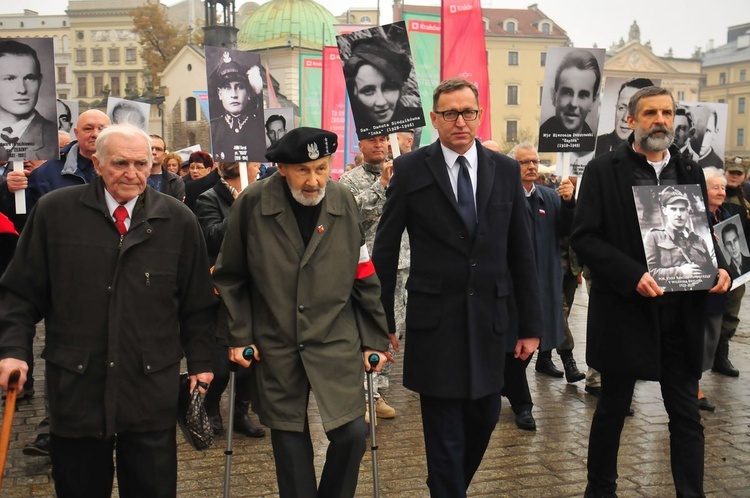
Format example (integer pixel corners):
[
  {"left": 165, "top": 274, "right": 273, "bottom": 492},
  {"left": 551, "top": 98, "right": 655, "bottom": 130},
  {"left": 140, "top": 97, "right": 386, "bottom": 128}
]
[{"left": 321, "top": 47, "right": 346, "bottom": 180}]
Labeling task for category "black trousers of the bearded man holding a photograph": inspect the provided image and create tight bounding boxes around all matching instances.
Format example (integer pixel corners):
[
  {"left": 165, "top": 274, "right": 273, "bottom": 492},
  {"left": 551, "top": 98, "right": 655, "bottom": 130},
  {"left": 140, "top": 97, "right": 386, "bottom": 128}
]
[{"left": 588, "top": 306, "right": 704, "bottom": 498}]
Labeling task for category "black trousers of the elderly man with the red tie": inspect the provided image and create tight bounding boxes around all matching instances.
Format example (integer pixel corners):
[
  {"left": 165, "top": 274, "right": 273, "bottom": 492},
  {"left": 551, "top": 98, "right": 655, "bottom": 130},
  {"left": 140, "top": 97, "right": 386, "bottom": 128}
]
[{"left": 50, "top": 427, "right": 177, "bottom": 498}]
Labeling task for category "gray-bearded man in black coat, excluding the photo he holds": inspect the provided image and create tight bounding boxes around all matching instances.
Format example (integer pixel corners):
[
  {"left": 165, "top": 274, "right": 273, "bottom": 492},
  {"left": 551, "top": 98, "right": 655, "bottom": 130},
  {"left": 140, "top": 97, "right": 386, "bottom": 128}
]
[{"left": 570, "top": 86, "right": 730, "bottom": 498}]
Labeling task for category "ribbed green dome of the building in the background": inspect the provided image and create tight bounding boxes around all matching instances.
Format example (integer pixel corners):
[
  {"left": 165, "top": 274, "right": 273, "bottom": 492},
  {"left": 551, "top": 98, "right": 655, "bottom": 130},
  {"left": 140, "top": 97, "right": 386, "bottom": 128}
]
[{"left": 237, "top": 0, "right": 337, "bottom": 50}]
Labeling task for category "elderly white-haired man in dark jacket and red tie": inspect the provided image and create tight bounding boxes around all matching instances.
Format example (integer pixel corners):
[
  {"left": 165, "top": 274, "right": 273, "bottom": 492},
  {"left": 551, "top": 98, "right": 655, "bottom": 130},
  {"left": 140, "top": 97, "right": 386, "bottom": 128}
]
[{"left": 0, "top": 125, "right": 215, "bottom": 497}]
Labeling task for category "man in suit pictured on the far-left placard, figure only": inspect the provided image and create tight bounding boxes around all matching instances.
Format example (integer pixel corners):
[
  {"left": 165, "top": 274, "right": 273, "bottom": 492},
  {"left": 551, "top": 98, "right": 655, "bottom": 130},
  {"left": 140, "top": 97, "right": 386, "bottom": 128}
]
[{"left": 0, "top": 39, "right": 59, "bottom": 161}]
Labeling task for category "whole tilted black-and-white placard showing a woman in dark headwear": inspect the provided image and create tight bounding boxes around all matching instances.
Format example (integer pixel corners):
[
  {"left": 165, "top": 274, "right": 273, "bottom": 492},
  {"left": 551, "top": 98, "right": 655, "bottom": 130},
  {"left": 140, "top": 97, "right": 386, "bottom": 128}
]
[{"left": 336, "top": 21, "right": 425, "bottom": 140}]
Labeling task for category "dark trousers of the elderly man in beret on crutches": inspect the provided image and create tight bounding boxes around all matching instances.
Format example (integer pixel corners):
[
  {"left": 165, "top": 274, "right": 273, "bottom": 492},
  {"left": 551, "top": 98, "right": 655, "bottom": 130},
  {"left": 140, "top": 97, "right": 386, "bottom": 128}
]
[{"left": 271, "top": 417, "right": 367, "bottom": 498}]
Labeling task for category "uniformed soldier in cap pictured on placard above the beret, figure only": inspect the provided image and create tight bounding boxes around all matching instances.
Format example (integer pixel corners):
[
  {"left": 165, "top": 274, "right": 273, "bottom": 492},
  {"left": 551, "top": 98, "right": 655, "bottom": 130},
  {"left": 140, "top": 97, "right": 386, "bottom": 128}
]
[{"left": 210, "top": 52, "right": 266, "bottom": 162}]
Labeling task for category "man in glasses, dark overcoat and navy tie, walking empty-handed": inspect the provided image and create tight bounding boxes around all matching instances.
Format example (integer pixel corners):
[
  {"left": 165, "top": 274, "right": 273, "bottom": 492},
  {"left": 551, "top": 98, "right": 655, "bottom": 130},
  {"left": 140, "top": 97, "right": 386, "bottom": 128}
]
[{"left": 373, "top": 78, "right": 542, "bottom": 498}]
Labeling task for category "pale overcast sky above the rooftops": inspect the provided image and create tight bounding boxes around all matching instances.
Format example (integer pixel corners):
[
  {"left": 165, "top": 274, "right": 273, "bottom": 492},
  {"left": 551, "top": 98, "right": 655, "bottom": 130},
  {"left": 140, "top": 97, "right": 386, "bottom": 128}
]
[{"left": 0, "top": 0, "right": 750, "bottom": 57}]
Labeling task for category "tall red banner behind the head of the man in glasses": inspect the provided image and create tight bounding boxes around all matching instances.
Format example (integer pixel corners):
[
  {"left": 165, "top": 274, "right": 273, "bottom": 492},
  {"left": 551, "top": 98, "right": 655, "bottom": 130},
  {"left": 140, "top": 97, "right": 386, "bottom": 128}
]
[{"left": 440, "top": 0, "right": 492, "bottom": 140}]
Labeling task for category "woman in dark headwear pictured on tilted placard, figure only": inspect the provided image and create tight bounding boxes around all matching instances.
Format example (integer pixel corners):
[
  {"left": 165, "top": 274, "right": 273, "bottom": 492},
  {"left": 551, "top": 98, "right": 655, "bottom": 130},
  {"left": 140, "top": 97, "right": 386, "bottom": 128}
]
[{"left": 344, "top": 37, "right": 422, "bottom": 138}]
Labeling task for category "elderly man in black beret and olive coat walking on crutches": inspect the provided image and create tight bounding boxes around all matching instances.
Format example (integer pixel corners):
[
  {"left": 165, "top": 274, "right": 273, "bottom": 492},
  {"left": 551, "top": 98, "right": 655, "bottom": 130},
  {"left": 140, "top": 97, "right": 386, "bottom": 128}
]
[{"left": 214, "top": 128, "right": 389, "bottom": 498}]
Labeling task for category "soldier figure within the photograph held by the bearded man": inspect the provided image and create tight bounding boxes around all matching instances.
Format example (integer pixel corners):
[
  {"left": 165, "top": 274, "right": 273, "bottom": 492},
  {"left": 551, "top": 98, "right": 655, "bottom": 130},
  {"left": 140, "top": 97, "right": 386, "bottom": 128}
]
[{"left": 644, "top": 187, "right": 716, "bottom": 290}]
